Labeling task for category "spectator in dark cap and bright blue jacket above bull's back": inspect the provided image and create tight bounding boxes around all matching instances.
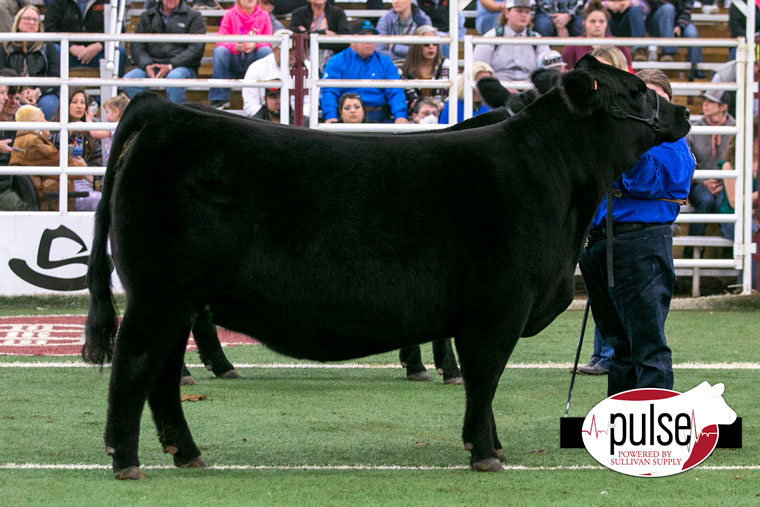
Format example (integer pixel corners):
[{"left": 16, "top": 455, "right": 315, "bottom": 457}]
[{"left": 321, "top": 20, "right": 409, "bottom": 123}]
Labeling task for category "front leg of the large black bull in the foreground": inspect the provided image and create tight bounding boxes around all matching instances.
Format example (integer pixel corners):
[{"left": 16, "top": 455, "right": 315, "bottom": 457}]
[{"left": 456, "top": 337, "right": 517, "bottom": 471}]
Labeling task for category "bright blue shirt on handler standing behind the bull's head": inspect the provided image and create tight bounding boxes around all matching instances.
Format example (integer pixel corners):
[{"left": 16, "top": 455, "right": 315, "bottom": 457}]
[{"left": 591, "top": 137, "right": 696, "bottom": 229}]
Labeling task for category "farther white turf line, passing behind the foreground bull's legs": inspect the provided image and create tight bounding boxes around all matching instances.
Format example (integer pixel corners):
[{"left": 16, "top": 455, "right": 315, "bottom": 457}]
[{"left": 0, "top": 361, "right": 760, "bottom": 370}]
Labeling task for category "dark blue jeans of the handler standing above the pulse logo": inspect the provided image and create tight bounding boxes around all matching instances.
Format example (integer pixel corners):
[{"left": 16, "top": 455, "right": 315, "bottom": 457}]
[{"left": 580, "top": 224, "right": 675, "bottom": 396}]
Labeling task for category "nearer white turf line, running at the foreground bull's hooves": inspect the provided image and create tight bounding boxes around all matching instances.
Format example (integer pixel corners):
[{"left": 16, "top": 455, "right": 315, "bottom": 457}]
[{"left": 0, "top": 463, "right": 760, "bottom": 472}]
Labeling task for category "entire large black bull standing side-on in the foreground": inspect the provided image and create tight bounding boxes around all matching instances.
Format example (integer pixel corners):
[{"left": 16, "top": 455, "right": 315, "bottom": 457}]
[{"left": 83, "top": 57, "right": 689, "bottom": 478}]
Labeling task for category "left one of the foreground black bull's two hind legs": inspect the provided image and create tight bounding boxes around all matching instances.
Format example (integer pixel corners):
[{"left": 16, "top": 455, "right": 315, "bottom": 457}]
[{"left": 105, "top": 302, "right": 190, "bottom": 479}]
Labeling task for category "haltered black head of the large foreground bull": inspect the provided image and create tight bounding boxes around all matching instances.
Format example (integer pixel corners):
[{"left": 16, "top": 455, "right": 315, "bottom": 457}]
[{"left": 562, "top": 55, "right": 691, "bottom": 144}]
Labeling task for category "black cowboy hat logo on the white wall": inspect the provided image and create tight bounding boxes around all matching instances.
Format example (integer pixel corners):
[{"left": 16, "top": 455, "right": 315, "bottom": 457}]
[{"left": 8, "top": 225, "right": 100, "bottom": 291}]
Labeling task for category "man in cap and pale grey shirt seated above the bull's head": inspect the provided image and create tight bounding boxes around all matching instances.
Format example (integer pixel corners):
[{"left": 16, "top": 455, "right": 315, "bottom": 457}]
[{"left": 472, "top": 0, "right": 551, "bottom": 81}]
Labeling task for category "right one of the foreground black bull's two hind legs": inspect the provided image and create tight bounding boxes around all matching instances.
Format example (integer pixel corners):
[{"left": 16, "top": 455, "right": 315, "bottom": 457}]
[{"left": 148, "top": 327, "right": 206, "bottom": 467}]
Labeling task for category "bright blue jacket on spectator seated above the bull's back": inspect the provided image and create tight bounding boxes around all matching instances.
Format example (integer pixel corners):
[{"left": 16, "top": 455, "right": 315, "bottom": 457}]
[{"left": 321, "top": 48, "right": 406, "bottom": 120}]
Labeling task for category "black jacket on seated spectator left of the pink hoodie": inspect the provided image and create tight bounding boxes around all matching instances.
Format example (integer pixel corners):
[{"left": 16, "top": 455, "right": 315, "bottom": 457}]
[{"left": 132, "top": 0, "right": 206, "bottom": 74}]
